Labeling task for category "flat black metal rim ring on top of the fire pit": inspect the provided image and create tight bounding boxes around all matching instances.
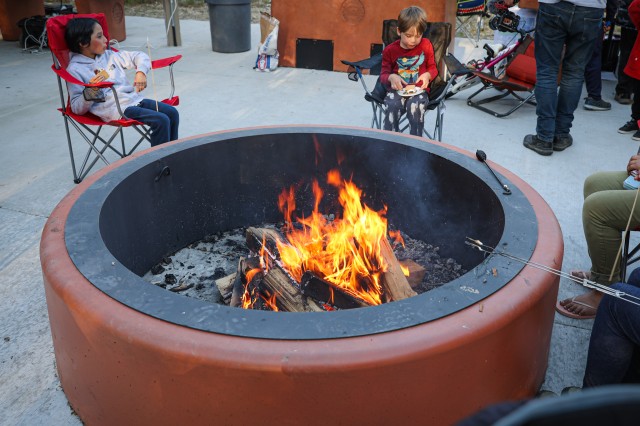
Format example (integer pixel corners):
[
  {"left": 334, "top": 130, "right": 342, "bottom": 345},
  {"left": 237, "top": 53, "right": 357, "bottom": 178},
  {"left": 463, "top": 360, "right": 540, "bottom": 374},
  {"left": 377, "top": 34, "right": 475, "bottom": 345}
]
[{"left": 65, "top": 126, "right": 538, "bottom": 340}]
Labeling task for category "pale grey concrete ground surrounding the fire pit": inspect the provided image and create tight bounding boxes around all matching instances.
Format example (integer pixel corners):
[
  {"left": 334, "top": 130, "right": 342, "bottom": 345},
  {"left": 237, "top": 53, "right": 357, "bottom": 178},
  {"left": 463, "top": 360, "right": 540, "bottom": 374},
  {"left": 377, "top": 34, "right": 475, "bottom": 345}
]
[{"left": 0, "top": 17, "right": 638, "bottom": 425}]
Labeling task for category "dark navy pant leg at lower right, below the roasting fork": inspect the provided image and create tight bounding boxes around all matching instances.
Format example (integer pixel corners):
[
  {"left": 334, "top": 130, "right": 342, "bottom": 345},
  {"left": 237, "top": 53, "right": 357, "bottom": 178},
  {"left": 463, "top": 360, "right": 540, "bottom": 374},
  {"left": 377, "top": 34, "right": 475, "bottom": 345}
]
[{"left": 582, "top": 283, "right": 640, "bottom": 388}]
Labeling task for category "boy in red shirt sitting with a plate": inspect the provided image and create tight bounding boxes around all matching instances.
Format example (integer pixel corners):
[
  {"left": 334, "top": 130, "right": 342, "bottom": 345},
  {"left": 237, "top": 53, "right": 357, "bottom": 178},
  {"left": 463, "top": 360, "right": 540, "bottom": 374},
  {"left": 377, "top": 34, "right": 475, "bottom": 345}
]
[{"left": 380, "top": 6, "right": 438, "bottom": 136}]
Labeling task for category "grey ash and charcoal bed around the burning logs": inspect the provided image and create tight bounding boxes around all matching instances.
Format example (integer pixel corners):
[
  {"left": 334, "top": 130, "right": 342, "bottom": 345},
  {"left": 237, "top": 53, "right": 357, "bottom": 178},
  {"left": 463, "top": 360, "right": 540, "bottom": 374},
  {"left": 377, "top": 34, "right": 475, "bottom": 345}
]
[{"left": 143, "top": 224, "right": 466, "bottom": 304}]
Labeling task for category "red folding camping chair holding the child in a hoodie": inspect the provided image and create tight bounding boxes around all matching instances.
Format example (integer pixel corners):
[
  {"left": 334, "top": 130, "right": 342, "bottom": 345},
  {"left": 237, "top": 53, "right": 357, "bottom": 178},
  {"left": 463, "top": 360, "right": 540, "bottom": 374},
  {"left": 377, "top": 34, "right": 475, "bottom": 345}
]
[{"left": 47, "top": 13, "right": 182, "bottom": 183}]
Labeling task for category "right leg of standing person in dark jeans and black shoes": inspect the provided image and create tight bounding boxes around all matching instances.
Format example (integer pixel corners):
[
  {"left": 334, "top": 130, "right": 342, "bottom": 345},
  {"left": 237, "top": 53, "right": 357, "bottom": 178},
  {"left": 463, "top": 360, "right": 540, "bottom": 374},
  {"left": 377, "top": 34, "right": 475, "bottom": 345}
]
[{"left": 552, "top": 2, "right": 602, "bottom": 137}]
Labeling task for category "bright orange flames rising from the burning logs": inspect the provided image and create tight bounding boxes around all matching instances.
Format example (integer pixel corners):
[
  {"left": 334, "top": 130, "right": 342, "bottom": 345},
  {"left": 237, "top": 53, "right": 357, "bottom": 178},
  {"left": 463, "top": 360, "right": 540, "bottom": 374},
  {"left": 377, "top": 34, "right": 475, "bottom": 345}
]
[{"left": 277, "top": 170, "right": 402, "bottom": 305}]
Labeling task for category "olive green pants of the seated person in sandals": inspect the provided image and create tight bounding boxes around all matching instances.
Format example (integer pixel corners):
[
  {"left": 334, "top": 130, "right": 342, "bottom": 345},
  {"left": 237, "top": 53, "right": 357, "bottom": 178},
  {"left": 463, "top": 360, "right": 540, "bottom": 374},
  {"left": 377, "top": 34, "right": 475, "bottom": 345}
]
[{"left": 582, "top": 172, "right": 640, "bottom": 284}]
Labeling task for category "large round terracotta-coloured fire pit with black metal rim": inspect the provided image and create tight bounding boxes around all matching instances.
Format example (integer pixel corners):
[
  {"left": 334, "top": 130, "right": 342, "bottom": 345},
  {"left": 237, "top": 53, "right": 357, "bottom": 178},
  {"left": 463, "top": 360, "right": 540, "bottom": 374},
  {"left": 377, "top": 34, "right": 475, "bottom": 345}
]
[{"left": 41, "top": 126, "right": 563, "bottom": 425}]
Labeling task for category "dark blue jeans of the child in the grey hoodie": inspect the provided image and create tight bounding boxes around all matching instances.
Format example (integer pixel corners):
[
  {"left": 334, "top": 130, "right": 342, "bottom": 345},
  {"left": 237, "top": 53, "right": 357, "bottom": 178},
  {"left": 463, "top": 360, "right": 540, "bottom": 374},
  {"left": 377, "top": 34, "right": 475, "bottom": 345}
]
[{"left": 124, "top": 99, "right": 180, "bottom": 146}]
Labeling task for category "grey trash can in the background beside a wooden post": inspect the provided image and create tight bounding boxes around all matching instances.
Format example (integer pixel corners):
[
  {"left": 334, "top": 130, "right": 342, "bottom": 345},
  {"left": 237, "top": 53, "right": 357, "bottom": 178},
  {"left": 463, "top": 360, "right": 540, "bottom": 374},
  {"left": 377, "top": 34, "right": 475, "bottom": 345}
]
[{"left": 205, "top": 0, "right": 251, "bottom": 53}]
